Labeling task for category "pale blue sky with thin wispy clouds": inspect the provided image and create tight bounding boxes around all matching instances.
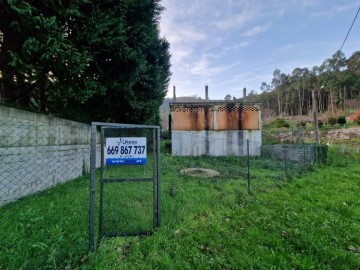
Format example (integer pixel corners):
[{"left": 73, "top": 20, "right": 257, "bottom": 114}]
[{"left": 160, "top": 0, "right": 360, "bottom": 100}]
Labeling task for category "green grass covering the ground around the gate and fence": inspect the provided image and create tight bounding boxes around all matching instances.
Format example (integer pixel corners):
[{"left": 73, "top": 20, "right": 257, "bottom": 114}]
[{"left": 0, "top": 148, "right": 360, "bottom": 269}]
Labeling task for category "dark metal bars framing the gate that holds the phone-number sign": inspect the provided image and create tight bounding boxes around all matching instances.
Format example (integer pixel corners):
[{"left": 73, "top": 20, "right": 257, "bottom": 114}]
[{"left": 89, "top": 122, "right": 161, "bottom": 251}]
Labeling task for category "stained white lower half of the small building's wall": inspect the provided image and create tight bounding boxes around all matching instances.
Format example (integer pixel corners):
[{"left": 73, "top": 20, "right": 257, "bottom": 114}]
[{"left": 171, "top": 130, "right": 261, "bottom": 156}]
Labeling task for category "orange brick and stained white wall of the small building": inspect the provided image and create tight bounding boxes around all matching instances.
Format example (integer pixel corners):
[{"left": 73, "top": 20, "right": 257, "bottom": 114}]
[{"left": 170, "top": 102, "right": 261, "bottom": 156}]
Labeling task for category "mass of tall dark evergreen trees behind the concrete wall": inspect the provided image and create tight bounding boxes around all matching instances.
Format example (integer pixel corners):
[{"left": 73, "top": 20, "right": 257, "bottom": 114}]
[{"left": 0, "top": 0, "right": 170, "bottom": 123}]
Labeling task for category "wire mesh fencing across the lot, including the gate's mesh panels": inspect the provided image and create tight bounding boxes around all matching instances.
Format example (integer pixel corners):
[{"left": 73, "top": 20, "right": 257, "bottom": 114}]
[{"left": 0, "top": 117, "right": 359, "bottom": 269}]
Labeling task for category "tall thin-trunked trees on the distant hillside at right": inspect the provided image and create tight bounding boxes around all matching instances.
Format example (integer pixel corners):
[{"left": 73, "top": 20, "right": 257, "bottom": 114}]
[{"left": 245, "top": 51, "right": 360, "bottom": 116}]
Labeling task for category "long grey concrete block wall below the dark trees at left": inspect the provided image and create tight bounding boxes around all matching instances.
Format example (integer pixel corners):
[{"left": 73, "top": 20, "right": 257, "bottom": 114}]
[{"left": 0, "top": 106, "right": 100, "bottom": 205}]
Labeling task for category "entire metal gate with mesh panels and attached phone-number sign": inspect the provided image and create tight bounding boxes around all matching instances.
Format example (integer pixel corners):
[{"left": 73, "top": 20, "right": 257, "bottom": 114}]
[{"left": 89, "top": 122, "right": 161, "bottom": 250}]
